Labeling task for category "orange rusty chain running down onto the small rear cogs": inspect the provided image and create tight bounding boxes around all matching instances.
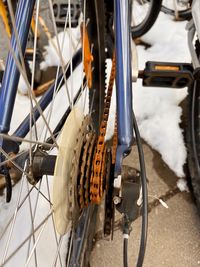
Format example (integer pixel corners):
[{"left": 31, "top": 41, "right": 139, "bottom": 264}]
[{"left": 90, "top": 55, "right": 116, "bottom": 204}]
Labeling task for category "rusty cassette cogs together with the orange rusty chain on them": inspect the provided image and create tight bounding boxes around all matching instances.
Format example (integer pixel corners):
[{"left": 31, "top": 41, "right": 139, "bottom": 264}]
[{"left": 65, "top": 53, "right": 116, "bottom": 231}]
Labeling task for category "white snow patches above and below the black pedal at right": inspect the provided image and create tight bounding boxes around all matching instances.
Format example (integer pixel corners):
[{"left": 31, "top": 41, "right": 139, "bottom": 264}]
[{"left": 133, "top": 13, "right": 190, "bottom": 177}]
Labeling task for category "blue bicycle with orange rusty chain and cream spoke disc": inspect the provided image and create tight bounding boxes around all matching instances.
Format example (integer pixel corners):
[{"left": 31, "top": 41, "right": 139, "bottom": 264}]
[{"left": 0, "top": 0, "right": 147, "bottom": 266}]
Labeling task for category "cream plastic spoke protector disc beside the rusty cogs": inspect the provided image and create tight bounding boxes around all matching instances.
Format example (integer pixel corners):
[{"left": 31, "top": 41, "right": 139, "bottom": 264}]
[{"left": 52, "top": 108, "right": 84, "bottom": 235}]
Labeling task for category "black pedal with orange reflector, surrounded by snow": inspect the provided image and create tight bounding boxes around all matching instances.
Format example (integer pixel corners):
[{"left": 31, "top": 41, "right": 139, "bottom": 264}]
[{"left": 139, "top": 61, "right": 194, "bottom": 88}]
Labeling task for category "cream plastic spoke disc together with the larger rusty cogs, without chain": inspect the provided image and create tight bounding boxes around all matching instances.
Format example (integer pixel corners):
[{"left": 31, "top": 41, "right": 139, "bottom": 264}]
[{"left": 53, "top": 108, "right": 96, "bottom": 235}]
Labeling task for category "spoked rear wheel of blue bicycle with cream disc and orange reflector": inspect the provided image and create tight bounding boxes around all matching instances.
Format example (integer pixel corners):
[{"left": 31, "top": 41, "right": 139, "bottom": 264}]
[{"left": 0, "top": 0, "right": 105, "bottom": 266}]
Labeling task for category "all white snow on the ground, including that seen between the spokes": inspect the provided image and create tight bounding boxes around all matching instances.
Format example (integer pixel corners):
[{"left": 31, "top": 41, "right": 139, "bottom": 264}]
[{"left": 0, "top": 9, "right": 190, "bottom": 266}]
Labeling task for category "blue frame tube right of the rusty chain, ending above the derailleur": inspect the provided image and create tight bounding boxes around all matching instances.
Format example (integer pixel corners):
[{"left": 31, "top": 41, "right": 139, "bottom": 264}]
[{"left": 114, "top": 0, "right": 134, "bottom": 176}]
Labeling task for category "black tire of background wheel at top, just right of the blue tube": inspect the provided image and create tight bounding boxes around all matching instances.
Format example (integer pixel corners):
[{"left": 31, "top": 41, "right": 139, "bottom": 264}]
[{"left": 131, "top": 0, "right": 162, "bottom": 39}]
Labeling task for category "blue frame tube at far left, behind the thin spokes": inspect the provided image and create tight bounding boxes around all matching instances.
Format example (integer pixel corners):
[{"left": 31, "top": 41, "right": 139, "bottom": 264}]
[{"left": 0, "top": 0, "right": 35, "bottom": 133}]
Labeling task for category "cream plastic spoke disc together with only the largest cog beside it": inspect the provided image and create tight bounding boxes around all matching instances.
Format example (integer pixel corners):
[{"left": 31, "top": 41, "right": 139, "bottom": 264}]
[{"left": 53, "top": 108, "right": 92, "bottom": 235}]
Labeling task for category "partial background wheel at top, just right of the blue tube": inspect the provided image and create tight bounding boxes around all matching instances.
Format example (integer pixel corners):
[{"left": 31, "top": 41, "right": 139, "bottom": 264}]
[{"left": 131, "top": 0, "right": 162, "bottom": 38}]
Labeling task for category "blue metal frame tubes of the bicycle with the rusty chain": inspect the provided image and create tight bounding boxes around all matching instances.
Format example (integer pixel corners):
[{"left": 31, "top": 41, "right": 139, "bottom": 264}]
[{"left": 0, "top": 0, "right": 133, "bottom": 177}]
